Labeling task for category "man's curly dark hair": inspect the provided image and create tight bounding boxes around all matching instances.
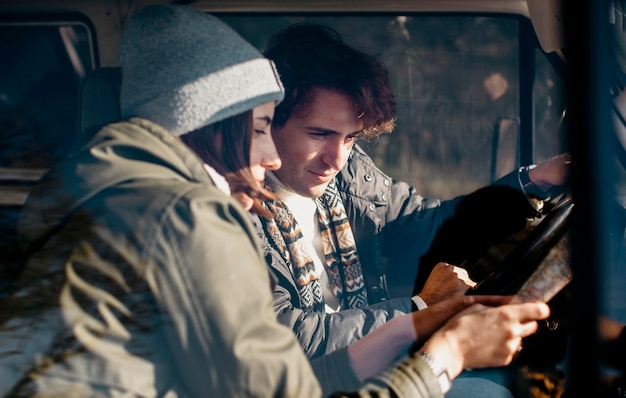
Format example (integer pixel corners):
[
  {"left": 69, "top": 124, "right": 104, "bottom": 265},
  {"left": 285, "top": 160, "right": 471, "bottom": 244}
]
[{"left": 264, "top": 23, "right": 396, "bottom": 140}]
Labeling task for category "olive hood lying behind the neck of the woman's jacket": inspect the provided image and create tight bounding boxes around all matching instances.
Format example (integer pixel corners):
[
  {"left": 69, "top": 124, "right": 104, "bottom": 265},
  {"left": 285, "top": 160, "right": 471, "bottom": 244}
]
[{"left": 17, "top": 118, "right": 212, "bottom": 252}]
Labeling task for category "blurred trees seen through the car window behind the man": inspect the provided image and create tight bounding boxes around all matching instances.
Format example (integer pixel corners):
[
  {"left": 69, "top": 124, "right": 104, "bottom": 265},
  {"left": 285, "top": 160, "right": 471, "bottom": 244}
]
[{"left": 220, "top": 14, "right": 562, "bottom": 198}]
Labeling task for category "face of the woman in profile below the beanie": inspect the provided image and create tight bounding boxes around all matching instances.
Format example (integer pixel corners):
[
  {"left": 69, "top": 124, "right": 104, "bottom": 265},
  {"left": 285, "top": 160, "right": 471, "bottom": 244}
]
[{"left": 243, "top": 101, "right": 281, "bottom": 210}]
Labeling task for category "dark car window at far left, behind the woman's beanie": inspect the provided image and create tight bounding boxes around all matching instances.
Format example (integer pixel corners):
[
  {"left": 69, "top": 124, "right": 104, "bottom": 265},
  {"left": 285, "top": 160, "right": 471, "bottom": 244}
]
[{"left": 0, "top": 23, "right": 94, "bottom": 169}]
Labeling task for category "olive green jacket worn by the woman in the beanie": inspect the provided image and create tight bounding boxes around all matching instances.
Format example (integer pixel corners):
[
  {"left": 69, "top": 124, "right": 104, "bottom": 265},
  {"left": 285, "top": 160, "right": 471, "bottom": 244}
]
[{"left": 0, "top": 118, "right": 438, "bottom": 397}]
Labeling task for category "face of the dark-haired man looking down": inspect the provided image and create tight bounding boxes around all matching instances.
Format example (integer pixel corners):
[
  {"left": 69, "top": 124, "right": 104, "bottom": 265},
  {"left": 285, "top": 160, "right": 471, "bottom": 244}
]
[{"left": 273, "top": 88, "right": 363, "bottom": 197}]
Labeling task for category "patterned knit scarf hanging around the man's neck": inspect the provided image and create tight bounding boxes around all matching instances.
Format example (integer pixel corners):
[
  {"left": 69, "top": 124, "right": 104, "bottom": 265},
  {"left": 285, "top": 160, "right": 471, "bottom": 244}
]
[{"left": 262, "top": 180, "right": 367, "bottom": 312}]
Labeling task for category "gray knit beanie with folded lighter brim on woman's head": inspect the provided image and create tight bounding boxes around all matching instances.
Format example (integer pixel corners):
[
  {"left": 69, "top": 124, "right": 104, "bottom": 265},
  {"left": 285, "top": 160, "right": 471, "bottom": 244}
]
[{"left": 119, "top": 5, "right": 284, "bottom": 136}]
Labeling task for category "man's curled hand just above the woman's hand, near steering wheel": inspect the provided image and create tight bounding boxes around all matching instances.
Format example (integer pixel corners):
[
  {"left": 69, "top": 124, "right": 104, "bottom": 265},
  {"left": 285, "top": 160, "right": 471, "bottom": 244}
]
[{"left": 419, "top": 263, "right": 476, "bottom": 306}]
